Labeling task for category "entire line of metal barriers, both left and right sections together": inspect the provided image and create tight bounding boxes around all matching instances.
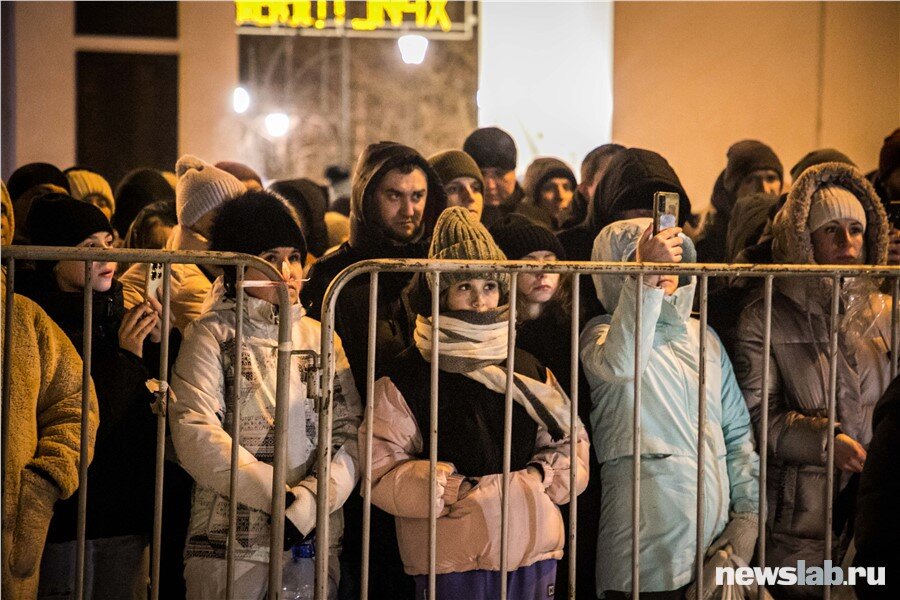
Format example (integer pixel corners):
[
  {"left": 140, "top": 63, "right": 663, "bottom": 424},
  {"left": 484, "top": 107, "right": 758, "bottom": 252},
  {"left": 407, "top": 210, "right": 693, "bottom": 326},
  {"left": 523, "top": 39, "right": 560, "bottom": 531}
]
[{"left": 2, "top": 246, "right": 900, "bottom": 600}]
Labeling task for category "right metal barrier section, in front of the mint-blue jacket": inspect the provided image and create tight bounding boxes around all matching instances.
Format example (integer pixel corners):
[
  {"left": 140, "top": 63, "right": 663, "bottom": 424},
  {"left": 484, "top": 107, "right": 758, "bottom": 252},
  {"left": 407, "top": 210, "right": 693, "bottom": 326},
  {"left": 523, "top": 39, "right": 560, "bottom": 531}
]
[{"left": 316, "top": 259, "right": 900, "bottom": 600}]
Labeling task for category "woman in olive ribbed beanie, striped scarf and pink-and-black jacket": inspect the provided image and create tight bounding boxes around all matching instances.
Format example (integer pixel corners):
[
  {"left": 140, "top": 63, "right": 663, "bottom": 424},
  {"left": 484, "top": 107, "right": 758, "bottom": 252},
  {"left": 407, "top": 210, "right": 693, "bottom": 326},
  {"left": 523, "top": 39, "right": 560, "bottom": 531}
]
[{"left": 360, "top": 207, "right": 588, "bottom": 600}]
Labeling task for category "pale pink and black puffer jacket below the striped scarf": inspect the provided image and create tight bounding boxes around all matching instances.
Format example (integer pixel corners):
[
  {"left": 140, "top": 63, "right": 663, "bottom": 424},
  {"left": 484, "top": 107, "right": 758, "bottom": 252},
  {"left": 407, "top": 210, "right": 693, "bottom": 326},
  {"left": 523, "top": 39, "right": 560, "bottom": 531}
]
[{"left": 359, "top": 347, "right": 589, "bottom": 575}]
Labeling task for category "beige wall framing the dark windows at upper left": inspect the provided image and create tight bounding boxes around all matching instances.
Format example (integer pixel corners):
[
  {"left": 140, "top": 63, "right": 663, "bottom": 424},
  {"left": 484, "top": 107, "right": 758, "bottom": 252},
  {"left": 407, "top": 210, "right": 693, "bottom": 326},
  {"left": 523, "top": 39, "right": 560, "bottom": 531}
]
[{"left": 11, "top": 2, "right": 238, "bottom": 177}]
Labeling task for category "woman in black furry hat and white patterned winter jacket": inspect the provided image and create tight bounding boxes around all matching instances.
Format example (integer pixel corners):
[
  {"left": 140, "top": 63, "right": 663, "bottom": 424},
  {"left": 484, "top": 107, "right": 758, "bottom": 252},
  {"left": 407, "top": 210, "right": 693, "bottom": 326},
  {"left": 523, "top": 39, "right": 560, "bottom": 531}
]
[{"left": 169, "top": 192, "right": 362, "bottom": 599}]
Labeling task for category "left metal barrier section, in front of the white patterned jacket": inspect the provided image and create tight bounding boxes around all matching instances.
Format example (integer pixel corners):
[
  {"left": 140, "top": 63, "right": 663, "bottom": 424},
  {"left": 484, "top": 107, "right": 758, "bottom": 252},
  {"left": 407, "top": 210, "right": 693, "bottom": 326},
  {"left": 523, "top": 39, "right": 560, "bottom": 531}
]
[{"left": 0, "top": 246, "right": 291, "bottom": 600}]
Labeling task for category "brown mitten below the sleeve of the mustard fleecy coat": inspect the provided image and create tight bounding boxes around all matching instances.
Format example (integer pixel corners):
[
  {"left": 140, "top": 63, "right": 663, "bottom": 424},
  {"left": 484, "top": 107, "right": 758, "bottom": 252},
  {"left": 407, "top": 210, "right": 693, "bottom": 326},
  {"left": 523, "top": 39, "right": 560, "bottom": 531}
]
[{"left": 9, "top": 469, "right": 59, "bottom": 578}]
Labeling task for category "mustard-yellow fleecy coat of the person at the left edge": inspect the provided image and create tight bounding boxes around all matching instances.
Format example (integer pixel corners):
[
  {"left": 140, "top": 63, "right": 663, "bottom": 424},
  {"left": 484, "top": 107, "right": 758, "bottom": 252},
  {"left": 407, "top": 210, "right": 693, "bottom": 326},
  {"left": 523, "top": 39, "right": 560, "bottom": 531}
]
[{"left": 0, "top": 277, "right": 98, "bottom": 598}]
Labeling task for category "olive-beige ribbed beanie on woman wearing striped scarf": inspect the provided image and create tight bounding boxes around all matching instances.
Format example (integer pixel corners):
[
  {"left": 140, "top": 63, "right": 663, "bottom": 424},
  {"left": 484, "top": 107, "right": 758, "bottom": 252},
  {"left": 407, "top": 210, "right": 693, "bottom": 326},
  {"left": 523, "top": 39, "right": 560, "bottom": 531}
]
[{"left": 427, "top": 206, "right": 509, "bottom": 294}]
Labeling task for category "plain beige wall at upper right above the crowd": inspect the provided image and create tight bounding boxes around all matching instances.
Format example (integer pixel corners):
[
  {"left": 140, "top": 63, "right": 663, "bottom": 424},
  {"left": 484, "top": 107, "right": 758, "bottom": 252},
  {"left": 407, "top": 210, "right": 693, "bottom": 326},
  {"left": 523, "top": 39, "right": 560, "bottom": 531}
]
[{"left": 613, "top": 2, "right": 900, "bottom": 209}]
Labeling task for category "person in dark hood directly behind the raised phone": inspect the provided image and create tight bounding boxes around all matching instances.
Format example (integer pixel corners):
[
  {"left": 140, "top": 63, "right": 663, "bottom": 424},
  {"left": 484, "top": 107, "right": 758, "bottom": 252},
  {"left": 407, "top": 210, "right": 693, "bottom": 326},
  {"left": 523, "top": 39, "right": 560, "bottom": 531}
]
[{"left": 557, "top": 148, "right": 691, "bottom": 320}]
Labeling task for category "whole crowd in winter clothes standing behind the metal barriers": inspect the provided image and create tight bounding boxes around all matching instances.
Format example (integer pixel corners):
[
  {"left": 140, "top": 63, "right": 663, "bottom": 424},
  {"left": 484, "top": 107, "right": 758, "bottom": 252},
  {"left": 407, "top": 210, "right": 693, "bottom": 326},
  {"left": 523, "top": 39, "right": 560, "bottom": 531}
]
[{"left": 2, "top": 127, "right": 900, "bottom": 600}]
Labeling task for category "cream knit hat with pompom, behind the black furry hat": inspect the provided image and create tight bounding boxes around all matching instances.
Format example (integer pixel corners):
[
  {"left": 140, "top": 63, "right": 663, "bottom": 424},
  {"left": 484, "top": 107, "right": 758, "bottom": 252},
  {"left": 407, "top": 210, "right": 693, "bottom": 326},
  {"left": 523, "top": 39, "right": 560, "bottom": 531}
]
[{"left": 175, "top": 154, "right": 244, "bottom": 229}]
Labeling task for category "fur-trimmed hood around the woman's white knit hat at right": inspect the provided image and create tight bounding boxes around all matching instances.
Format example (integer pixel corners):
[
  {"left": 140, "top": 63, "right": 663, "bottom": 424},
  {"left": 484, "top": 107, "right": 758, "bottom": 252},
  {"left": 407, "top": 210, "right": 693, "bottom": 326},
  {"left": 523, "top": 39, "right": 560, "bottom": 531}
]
[{"left": 772, "top": 162, "right": 889, "bottom": 265}]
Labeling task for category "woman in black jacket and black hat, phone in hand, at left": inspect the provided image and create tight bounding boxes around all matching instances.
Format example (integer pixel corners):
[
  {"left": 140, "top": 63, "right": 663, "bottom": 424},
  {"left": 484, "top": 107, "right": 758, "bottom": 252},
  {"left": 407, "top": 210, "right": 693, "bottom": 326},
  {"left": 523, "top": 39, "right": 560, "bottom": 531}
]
[{"left": 21, "top": 194, "right": 162, "bottom": 598}]
